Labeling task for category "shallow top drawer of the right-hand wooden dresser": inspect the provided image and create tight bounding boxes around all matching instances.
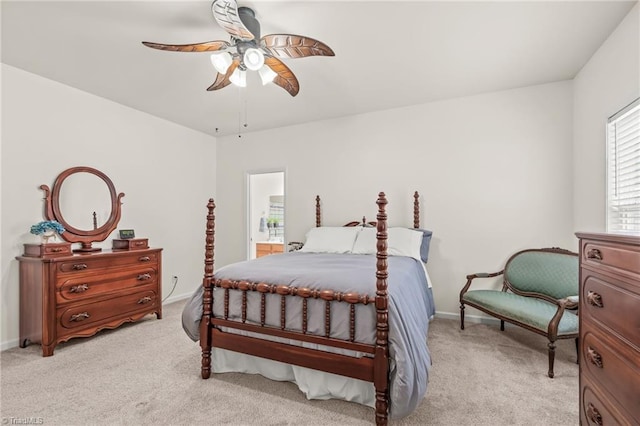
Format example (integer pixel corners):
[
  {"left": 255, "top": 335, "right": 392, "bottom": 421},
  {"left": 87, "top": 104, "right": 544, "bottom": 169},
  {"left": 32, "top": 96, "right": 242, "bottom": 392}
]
[{"left": 582, "top": 240, "right": 640, "bottom": 283}]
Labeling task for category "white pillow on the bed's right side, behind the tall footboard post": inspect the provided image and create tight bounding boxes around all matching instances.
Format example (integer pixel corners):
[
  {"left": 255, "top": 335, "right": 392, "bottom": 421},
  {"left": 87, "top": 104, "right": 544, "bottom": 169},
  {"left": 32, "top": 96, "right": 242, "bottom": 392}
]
[{"left": 352, "top": 228, "right": 422, "bottom": 260}]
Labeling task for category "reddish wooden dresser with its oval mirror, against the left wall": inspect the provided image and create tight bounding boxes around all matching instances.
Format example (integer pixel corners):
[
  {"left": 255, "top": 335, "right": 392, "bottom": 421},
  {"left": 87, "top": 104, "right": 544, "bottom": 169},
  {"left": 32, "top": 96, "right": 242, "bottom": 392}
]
[{"left": 16, "top": 166, "right": 162, "bottom": 357}]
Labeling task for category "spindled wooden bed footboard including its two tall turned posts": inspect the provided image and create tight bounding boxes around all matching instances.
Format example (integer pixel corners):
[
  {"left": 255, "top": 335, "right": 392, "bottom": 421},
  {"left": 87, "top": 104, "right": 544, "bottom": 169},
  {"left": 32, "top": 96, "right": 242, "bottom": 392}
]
[{"left": 200, "top": 192, "right": 389, "bottom": 425}]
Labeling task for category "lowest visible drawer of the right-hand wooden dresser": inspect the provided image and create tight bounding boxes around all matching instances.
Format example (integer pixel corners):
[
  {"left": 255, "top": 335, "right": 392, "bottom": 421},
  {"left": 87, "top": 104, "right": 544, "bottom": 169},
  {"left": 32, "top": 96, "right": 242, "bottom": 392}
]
[{"left": 580, "top": 379, "right": 633, "bottom": 426}]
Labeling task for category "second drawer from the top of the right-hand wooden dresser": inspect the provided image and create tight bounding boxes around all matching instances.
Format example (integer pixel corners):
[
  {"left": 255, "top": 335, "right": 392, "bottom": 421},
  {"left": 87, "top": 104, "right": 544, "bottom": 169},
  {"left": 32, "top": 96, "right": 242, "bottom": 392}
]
[{"left": 580, "top": 269, "right": 640, "bottom": 349}]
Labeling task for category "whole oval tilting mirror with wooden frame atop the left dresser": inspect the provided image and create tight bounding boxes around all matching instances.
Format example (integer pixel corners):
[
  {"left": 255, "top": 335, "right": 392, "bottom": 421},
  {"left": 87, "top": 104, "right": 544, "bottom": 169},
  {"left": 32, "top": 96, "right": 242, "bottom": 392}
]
[{"left": 40, "top": 167, "right": 124, "bottom": 252}]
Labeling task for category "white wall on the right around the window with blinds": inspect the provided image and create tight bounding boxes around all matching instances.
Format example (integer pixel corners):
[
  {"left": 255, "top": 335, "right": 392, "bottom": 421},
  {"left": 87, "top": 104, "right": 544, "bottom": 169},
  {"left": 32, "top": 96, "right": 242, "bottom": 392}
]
[{"left": 573, "top": 4, "right": 640, "bottom": 232}]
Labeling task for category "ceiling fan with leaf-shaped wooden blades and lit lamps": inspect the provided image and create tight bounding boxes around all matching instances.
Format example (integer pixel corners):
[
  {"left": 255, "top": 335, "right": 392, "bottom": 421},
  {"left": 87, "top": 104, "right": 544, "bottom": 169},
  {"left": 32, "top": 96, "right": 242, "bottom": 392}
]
[{"left": 142, "top": 0, "right": 335, "bottom": 96}]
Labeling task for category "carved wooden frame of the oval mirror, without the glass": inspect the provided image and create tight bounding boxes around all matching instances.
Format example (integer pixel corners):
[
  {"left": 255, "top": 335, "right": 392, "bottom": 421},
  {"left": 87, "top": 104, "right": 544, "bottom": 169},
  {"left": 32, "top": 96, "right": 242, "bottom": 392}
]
[{"left": 40, "top": 166, "right": 124, "bottom": 252}]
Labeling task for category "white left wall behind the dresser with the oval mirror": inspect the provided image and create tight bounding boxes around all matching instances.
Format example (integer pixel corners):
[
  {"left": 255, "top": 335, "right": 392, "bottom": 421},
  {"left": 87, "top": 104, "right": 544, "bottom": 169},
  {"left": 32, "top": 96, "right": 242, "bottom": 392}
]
[{"left": 0, "top": 64, "right": 216, "bottom": 348}]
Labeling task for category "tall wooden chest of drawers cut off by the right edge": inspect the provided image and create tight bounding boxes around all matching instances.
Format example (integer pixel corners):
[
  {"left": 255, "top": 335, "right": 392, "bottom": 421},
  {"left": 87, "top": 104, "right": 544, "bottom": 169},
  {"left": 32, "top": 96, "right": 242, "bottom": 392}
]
[{"left": 576, "top": 233, "right": 640, "bottom": 426}]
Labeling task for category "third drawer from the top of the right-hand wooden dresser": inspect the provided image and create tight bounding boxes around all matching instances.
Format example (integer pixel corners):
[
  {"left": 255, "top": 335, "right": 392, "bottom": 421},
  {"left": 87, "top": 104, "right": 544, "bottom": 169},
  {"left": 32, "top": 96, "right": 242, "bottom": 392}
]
[{"left": 580, "top": 321, "right": 640, "bottom": 422}]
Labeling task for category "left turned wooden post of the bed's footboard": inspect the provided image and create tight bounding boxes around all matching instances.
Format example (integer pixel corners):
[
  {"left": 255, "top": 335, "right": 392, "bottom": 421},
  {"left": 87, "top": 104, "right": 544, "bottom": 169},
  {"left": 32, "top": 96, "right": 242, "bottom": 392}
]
[{"left": 200, "top": 198, "right": 216, "bottom": 379}]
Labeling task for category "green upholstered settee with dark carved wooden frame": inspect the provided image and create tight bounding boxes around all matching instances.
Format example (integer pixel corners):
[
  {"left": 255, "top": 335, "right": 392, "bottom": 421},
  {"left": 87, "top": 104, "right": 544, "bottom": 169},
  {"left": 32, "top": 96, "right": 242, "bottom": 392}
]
[{"left": 460, "top": 248, "right": 579, "bottom": 377}]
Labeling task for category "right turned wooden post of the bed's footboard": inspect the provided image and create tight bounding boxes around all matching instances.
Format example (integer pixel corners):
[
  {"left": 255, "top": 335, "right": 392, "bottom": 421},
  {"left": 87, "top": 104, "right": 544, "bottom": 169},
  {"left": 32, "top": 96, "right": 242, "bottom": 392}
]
[{"left": 373, "top": 192, "right": 389, "bottom": 425}]
